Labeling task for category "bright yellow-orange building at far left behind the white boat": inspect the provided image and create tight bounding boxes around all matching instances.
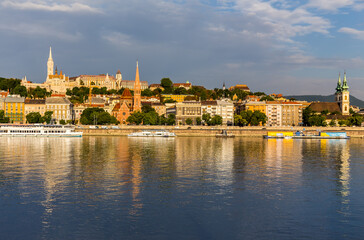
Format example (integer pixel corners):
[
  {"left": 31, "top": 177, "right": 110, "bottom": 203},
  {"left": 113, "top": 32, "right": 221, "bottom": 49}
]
[{"left": 4, "top": 95, "right": 25, "bottom": 123}]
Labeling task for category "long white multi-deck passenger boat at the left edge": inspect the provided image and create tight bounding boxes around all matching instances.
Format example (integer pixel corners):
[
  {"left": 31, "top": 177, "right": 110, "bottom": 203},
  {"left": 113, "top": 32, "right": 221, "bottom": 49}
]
[{"left": 0, "top": 124, "right": 82, "bottom": 137}]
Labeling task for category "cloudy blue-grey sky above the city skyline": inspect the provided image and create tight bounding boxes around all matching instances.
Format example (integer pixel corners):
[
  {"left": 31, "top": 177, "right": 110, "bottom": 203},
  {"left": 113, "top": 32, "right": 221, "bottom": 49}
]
[{"left": 0, "top": 0, "right": 364, "bottom": 99}]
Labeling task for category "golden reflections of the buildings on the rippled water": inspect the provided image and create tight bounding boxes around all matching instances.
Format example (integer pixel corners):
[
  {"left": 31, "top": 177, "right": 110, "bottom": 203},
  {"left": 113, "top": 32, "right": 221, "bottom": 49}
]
[{"left": 0, "top": 137, "right": 351, "bottom": 236}]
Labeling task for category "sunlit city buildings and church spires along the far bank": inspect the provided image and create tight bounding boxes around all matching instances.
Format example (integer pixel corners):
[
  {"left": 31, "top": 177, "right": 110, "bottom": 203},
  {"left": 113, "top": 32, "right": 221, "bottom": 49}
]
[{"left": 0, "top": 46, "right": 351, "bottom": 126}]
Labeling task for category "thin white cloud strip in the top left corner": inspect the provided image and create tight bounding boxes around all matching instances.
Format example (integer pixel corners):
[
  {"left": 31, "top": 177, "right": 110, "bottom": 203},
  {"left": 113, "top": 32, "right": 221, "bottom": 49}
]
[{"left": 1, "top": 1, "right": 102, "bottom": 13}]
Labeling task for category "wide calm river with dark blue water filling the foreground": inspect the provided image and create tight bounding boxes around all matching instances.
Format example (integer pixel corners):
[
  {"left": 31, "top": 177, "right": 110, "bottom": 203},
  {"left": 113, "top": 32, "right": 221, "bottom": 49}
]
[{"left": 0, "top": 137, "right": 364, "bottom": 239}]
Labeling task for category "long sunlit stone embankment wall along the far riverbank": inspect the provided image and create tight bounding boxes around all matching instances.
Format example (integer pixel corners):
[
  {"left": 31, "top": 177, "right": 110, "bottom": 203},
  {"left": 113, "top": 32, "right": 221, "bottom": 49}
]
[{"left": 76, "top": 126, "right": 364, "bottom": 138}]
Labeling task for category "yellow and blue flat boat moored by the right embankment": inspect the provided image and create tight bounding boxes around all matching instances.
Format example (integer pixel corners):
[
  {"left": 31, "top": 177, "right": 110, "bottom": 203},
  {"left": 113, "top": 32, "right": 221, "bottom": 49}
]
[{"left": 264, "top": 131, "right": 350, "bottom": 139}]
